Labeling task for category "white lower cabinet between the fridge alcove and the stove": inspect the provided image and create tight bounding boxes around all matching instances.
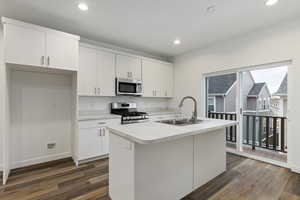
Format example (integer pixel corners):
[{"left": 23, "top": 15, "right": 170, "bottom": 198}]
[{"left": 79, "top": 122, "right": 109, "bottom": 161}]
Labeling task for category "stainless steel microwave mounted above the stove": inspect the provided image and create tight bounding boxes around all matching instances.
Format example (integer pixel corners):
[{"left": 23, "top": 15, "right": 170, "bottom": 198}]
[{"left": 116, "top": 78, "right": 143, "bottom": 96}]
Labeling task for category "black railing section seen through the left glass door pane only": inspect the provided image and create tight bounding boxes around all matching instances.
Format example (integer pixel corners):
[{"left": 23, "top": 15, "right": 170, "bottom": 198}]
[{"left": 208, "top": 112, "right": 237, "bottom": 142}]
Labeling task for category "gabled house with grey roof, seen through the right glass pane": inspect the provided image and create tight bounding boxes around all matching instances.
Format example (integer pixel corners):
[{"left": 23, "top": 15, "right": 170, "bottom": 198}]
[{"left": 245, "top": 83, "right": 271, "bottom": 113}]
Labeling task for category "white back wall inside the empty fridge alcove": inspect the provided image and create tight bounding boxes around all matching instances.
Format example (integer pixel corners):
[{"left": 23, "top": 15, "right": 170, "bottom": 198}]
[{"left": 10, "top": 71, "right": 72, "bottom": 168}]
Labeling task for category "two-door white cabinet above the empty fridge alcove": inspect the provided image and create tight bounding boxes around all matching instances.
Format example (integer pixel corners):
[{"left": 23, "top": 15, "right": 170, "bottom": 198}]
[{"left": 2, "top": 18, "right": 80, "bottom": 71}]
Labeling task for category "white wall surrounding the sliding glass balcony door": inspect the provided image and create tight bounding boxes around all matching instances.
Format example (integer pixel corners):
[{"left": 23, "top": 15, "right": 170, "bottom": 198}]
[{"left": 172, "top": 20, "right": 300, "bottom": 172}]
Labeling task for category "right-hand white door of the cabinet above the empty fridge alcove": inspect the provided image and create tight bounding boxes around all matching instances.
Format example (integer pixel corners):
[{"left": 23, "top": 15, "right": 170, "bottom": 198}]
[{"left": 46, "top": 32, "right": 79, "bottom": 71}]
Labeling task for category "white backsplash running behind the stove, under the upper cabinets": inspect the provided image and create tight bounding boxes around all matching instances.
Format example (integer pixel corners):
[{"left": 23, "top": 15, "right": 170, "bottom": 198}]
[{"left": 79, "top": 96, "right": 170, "bottom": 114}]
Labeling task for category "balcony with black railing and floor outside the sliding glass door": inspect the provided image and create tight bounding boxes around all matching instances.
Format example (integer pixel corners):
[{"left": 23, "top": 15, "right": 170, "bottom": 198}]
[{"left": 208, "top": 112, "right": 287, "bottom": 162}]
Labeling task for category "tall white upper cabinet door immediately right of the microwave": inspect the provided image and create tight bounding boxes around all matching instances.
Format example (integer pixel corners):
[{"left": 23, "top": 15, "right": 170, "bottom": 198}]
[{"left": 142, "top": 60, "right": 158, "bottom": 97}]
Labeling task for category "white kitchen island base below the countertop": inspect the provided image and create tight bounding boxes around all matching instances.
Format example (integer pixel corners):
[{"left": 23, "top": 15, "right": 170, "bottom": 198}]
[{"left": 109, "top": 126, "right": 226, "bottom": 200}]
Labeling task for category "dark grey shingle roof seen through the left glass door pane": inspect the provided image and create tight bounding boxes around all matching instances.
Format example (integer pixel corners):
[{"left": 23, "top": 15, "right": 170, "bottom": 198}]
[{"left": 208, "top": 73, "right": 236, "bottom": 95}]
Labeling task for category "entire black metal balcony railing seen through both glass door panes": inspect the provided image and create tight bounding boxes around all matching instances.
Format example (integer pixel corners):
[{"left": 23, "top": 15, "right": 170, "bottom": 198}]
[{"left": 208, "top": 112, "right": 287, "bottom": 153}]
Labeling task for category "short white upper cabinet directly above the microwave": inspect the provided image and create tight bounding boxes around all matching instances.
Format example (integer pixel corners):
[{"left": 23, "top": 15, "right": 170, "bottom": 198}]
[{"left": 116, "top": 54, "right": 142, "bottom": 80}]
